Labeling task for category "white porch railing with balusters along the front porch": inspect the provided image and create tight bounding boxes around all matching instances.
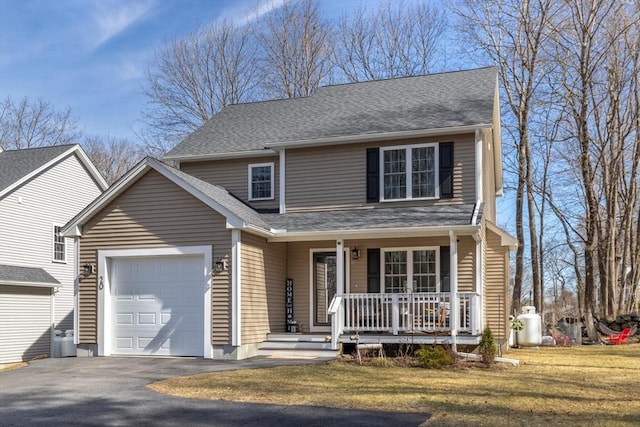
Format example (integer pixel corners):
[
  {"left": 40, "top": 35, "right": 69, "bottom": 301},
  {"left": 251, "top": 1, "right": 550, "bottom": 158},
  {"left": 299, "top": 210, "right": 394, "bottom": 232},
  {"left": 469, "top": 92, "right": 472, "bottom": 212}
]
[{"left": 329, "top": 292, "right": 480, "bottom": 349}]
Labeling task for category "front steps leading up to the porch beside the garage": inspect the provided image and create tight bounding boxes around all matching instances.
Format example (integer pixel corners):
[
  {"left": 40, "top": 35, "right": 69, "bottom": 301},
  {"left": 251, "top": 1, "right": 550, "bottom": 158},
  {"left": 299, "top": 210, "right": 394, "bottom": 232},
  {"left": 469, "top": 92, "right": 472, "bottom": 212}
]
[{"left": 258, "top": 334, "right": 338, "bottom": 359}]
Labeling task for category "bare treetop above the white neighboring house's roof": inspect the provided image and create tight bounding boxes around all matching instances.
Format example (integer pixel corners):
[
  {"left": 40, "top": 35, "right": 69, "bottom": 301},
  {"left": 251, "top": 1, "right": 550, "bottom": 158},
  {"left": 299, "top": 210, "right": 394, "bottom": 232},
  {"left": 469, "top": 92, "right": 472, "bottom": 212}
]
[{"left": 0, "top": 96, "right": 80, "bottom": 149}]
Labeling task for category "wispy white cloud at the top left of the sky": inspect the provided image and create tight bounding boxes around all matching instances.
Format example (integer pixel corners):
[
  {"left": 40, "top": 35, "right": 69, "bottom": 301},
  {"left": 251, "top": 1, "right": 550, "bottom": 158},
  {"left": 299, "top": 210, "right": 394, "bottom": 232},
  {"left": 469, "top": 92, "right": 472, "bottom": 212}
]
[{"left": 90, "top": 0, "right": 155, "bottom": 50}]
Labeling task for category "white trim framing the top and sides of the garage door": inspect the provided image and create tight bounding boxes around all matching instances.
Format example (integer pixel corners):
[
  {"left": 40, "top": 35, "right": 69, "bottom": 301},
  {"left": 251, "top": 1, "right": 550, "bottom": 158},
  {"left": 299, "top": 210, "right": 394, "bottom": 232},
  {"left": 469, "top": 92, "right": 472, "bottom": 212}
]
[{"left": 97, "top": 246, "right": 213, "bottom": 359}]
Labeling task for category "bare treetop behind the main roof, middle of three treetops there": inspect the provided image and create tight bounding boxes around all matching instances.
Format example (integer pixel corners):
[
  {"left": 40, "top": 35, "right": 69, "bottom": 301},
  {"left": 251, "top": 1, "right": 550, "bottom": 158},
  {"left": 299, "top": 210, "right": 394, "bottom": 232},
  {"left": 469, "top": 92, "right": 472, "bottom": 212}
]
[{"left": 256, "top": 0, "right": 332, "bottom": 98}]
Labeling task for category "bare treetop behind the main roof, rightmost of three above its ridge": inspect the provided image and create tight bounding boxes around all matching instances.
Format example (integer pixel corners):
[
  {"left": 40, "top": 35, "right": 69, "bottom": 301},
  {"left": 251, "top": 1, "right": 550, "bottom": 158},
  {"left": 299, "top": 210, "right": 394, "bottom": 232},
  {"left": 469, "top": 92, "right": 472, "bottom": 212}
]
[{"left": 334, "top": 1, "right": 447, "bottom": 82}]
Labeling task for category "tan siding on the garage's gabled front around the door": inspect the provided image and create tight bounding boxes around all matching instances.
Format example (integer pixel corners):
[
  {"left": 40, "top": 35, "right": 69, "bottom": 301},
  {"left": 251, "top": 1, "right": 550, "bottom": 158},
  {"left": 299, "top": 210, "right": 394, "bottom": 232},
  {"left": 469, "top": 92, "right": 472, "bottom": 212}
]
[{"left": 78, "top": 170, "right": 232, "bottom": 345}]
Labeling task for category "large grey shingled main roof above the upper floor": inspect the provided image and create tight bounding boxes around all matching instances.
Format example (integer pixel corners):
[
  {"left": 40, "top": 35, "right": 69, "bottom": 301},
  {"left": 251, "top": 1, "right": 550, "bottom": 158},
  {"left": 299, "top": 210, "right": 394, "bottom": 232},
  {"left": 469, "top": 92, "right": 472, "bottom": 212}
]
[{"left": 165, "top": 67, "right": 497, "bottom": 159}]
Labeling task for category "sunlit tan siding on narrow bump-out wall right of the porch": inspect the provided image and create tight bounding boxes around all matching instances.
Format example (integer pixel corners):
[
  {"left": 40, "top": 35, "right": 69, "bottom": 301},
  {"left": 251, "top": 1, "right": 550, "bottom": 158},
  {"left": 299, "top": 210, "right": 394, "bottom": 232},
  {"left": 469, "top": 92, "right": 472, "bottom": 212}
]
[{"left": 485, "top": 229, "right": 509, "bottom": 342}]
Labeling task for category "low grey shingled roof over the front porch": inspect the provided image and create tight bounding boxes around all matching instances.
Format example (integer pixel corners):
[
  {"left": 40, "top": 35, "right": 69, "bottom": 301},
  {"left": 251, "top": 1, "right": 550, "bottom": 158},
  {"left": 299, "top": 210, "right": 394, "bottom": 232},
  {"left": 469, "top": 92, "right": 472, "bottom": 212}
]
[{"left": 262, "top": 204, "right": 482, "bottom": 235}]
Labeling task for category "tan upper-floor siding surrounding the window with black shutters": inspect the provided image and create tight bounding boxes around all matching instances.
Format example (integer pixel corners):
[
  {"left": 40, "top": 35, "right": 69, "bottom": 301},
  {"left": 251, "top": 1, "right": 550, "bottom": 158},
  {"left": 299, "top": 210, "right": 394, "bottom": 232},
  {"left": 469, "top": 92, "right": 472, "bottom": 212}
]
[{"left": 285, "top": 134, "right": 475, "bottom": 211}]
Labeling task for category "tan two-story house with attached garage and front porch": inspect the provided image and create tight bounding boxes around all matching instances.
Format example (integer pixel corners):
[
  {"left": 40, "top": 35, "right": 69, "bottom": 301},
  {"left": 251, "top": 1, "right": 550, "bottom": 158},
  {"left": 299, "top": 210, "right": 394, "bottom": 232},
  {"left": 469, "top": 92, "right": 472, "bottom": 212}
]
[{"left": 64, "top": 68, "right": 515, "bottom": 358}]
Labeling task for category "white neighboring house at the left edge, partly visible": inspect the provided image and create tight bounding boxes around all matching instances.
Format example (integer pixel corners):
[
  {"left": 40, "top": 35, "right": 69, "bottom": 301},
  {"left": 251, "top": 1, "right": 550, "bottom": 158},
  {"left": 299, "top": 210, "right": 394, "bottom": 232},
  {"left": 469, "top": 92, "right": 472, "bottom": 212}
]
[{"left": 0, "top": 145, "right": 107, "bottom": 363}]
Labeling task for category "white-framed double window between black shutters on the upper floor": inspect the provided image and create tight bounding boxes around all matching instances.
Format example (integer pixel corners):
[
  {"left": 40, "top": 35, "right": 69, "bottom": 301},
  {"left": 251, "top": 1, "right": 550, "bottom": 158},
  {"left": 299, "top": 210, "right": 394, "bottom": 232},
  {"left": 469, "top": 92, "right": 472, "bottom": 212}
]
[{"left": 380, "top": 144, "right": 438, "bottom": 200}]
